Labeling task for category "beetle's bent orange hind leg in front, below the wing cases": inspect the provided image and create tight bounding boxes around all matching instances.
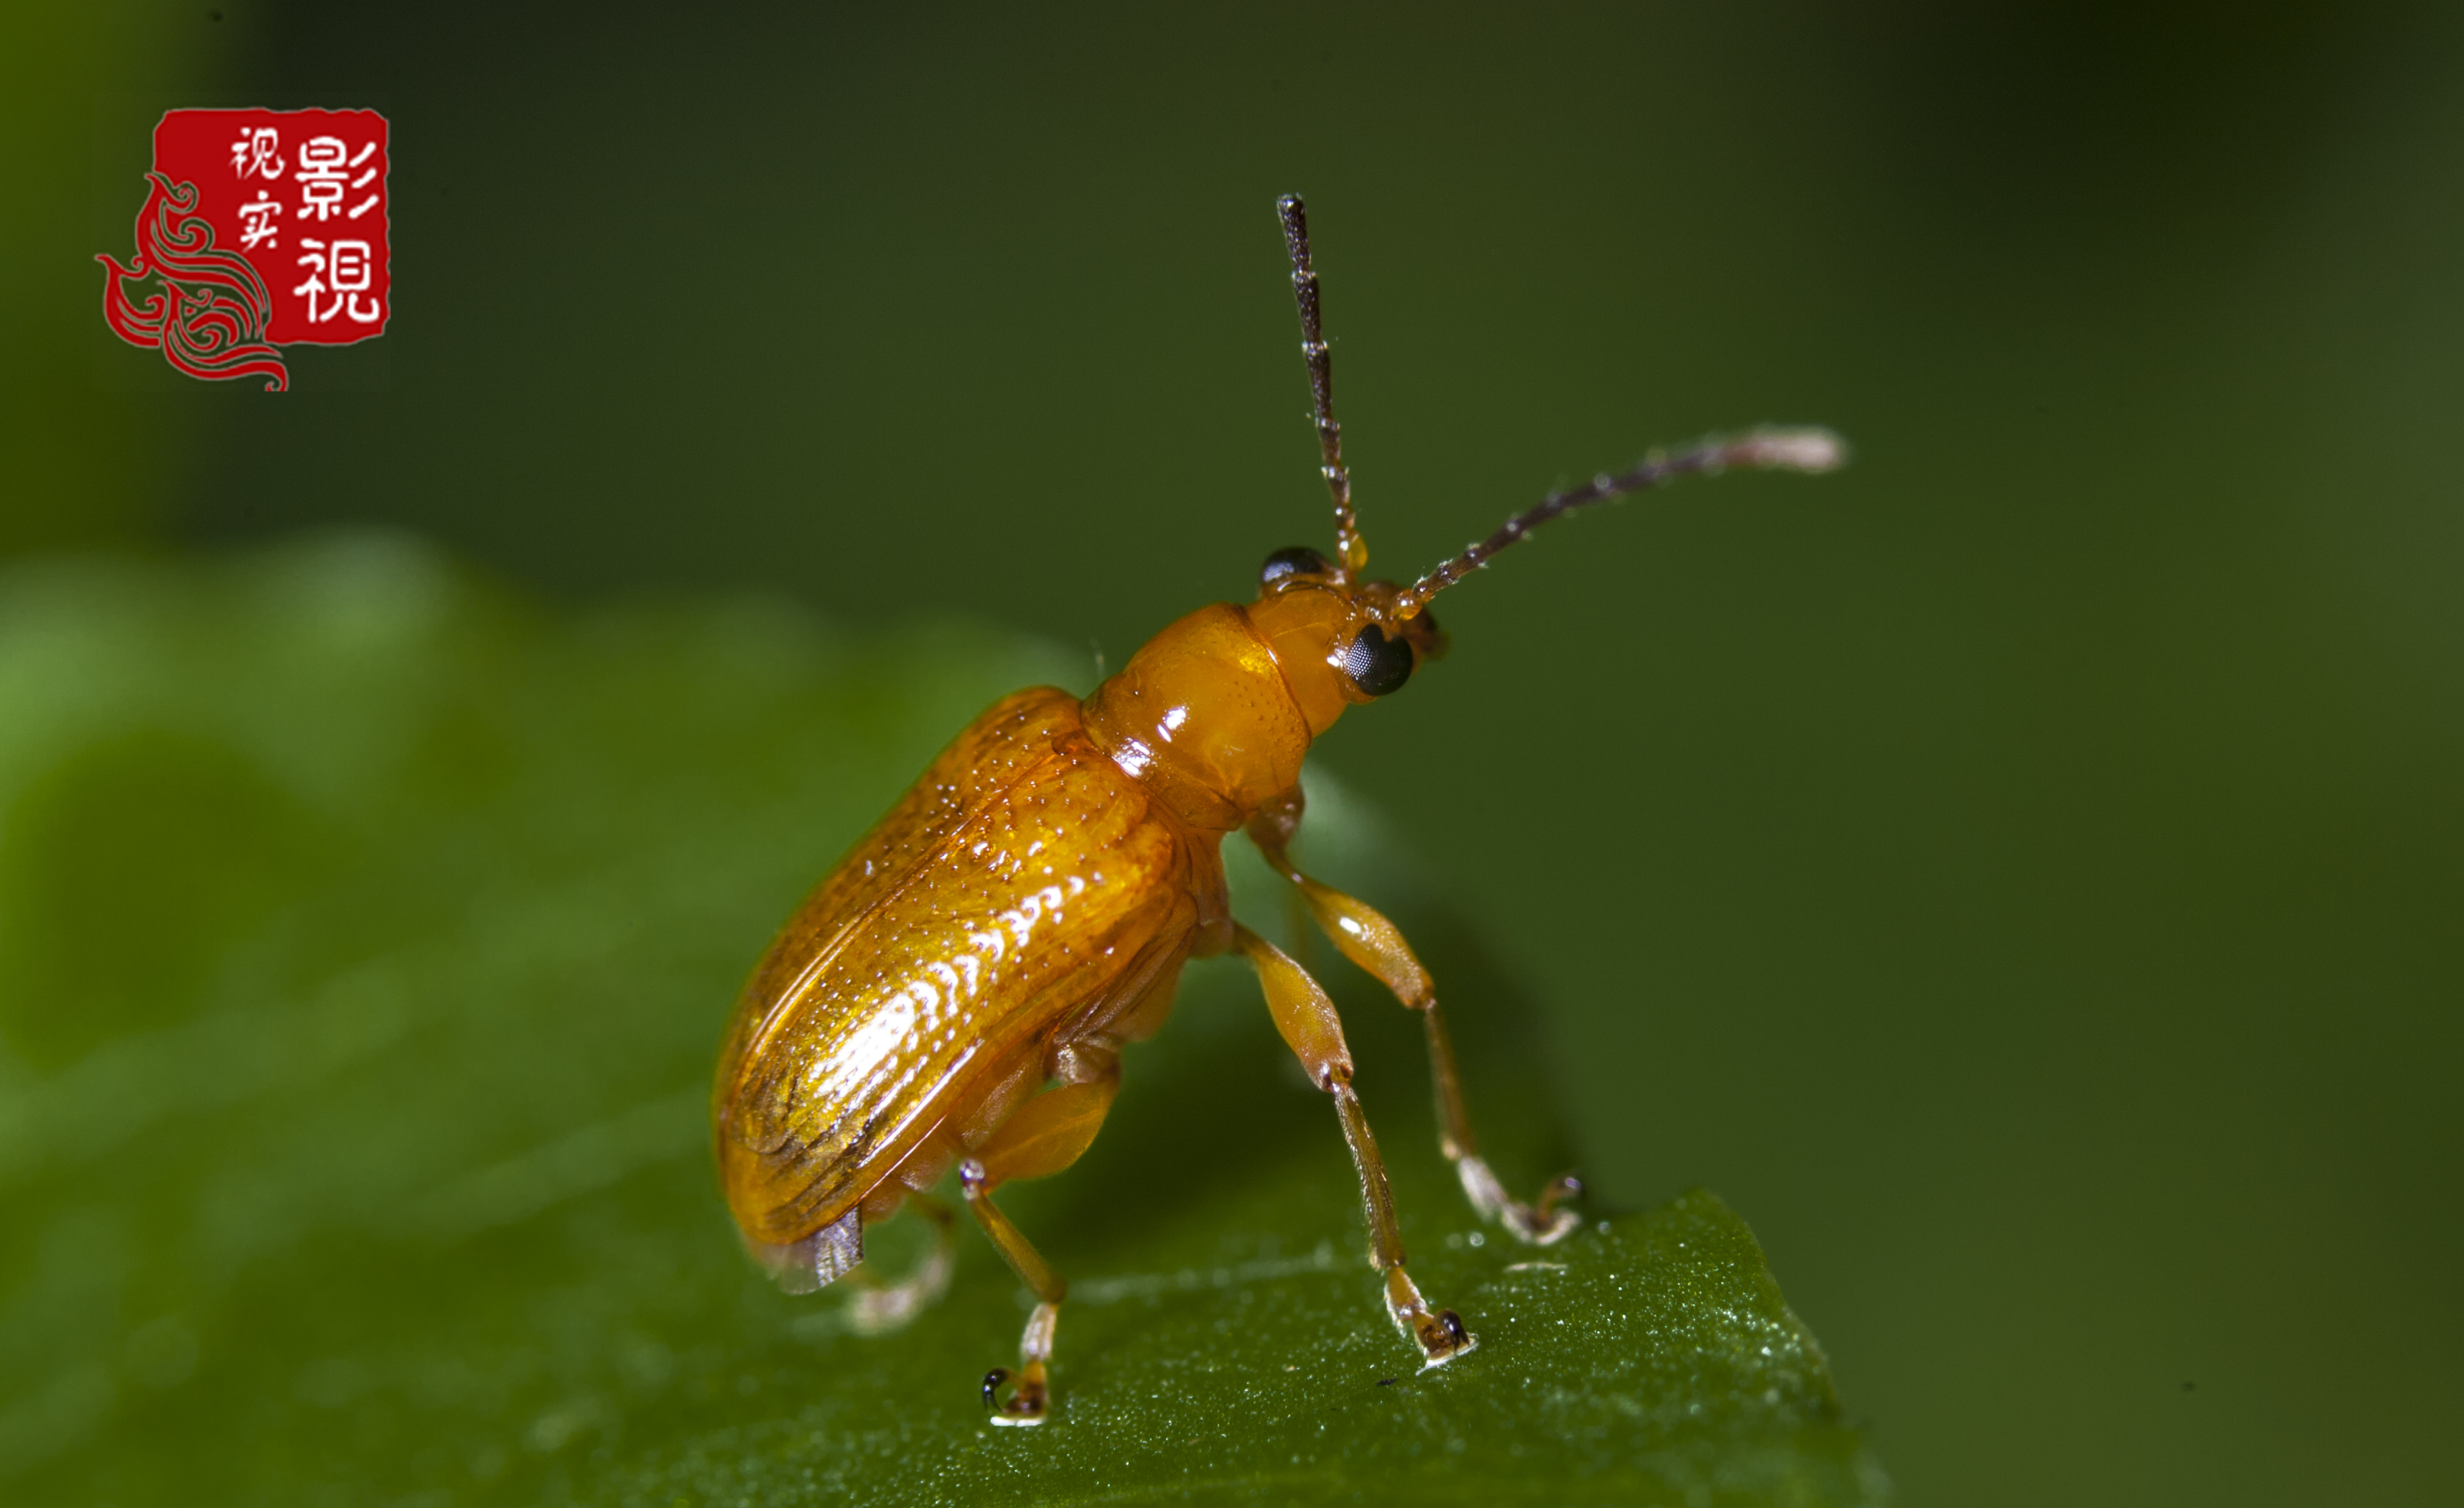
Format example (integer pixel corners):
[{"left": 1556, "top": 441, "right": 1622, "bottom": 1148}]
[{"left": 958, "top": 1045, "right": 1121, "bottom": 1424}]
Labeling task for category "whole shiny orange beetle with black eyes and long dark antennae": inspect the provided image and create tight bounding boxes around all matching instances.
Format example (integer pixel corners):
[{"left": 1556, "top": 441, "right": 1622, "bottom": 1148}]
[{"left": 712, "top": 197, "right": 1841, "bottom": 1424}]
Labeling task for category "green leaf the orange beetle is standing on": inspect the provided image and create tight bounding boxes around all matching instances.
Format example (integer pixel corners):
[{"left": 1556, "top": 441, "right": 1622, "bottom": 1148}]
[{"left": 0, "top": 539, "right": 1887, "bottom": 1506}]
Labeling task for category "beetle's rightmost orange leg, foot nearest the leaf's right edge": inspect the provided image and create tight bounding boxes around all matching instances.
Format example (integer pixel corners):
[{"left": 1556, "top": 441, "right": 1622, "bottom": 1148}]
[{"left": 1249, "top": 788, "right": 1582, "bottom": 1247}]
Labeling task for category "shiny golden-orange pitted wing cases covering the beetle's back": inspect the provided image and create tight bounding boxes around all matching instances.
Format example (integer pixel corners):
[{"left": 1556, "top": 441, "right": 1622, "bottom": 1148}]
[{"left": 714, "top": 690, "right": 1190, "bottom": 1244}]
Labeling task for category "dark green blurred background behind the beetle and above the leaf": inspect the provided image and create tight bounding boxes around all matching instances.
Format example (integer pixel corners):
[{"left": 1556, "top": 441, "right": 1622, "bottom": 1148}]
[{"left": 0, "top": 0, "right": 2464, "bottom": 1506}]
